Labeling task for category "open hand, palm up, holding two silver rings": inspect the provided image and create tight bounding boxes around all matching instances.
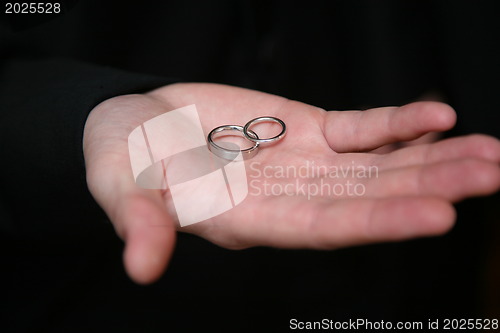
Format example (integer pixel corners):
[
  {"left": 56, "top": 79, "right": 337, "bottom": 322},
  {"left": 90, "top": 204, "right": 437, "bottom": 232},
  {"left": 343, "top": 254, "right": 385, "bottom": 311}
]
[{"left": 84, "top": 84, "right": 500, "bottom": 283}]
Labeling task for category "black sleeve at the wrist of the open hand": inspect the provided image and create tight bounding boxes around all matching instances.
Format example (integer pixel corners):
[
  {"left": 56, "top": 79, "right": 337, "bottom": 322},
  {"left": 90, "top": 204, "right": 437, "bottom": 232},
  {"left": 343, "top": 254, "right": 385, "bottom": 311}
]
[{"left": 0, "top": 59, "right": 172, "bottom": 238}]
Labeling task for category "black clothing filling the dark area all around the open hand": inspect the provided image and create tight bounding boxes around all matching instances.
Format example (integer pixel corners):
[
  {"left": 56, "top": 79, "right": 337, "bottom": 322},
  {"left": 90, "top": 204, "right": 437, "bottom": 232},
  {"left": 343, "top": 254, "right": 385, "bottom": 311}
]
[{"left": 0, "top": 0, "right": 500, "bottom": 332}]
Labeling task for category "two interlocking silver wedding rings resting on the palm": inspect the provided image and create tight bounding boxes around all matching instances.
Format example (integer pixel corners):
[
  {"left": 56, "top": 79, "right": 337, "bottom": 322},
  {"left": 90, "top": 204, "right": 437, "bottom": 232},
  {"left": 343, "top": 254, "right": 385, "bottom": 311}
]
[{"left": 208, "top": 116, "right": 286, "bottom": 160}]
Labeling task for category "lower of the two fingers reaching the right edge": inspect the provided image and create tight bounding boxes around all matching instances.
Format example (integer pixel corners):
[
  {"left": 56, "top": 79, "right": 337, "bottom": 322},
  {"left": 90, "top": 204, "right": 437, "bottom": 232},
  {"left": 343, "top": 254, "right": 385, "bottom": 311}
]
[{"left": 252, "top": 158, "right": 500, "bottom": 201}]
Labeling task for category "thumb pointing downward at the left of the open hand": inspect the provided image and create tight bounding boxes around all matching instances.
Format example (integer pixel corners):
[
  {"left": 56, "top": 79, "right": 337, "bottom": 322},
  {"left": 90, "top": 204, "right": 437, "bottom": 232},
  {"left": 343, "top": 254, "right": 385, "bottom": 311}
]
[{"left": 87, "top": 155, "right": 176, "bottom": 284}]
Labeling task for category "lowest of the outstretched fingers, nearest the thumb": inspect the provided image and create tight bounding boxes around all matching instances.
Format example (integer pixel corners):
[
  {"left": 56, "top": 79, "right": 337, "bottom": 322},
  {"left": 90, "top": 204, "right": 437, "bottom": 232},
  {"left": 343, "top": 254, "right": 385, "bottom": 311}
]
[{"left": 215, "top": 196, "right": 455, "bottom": 249}]
